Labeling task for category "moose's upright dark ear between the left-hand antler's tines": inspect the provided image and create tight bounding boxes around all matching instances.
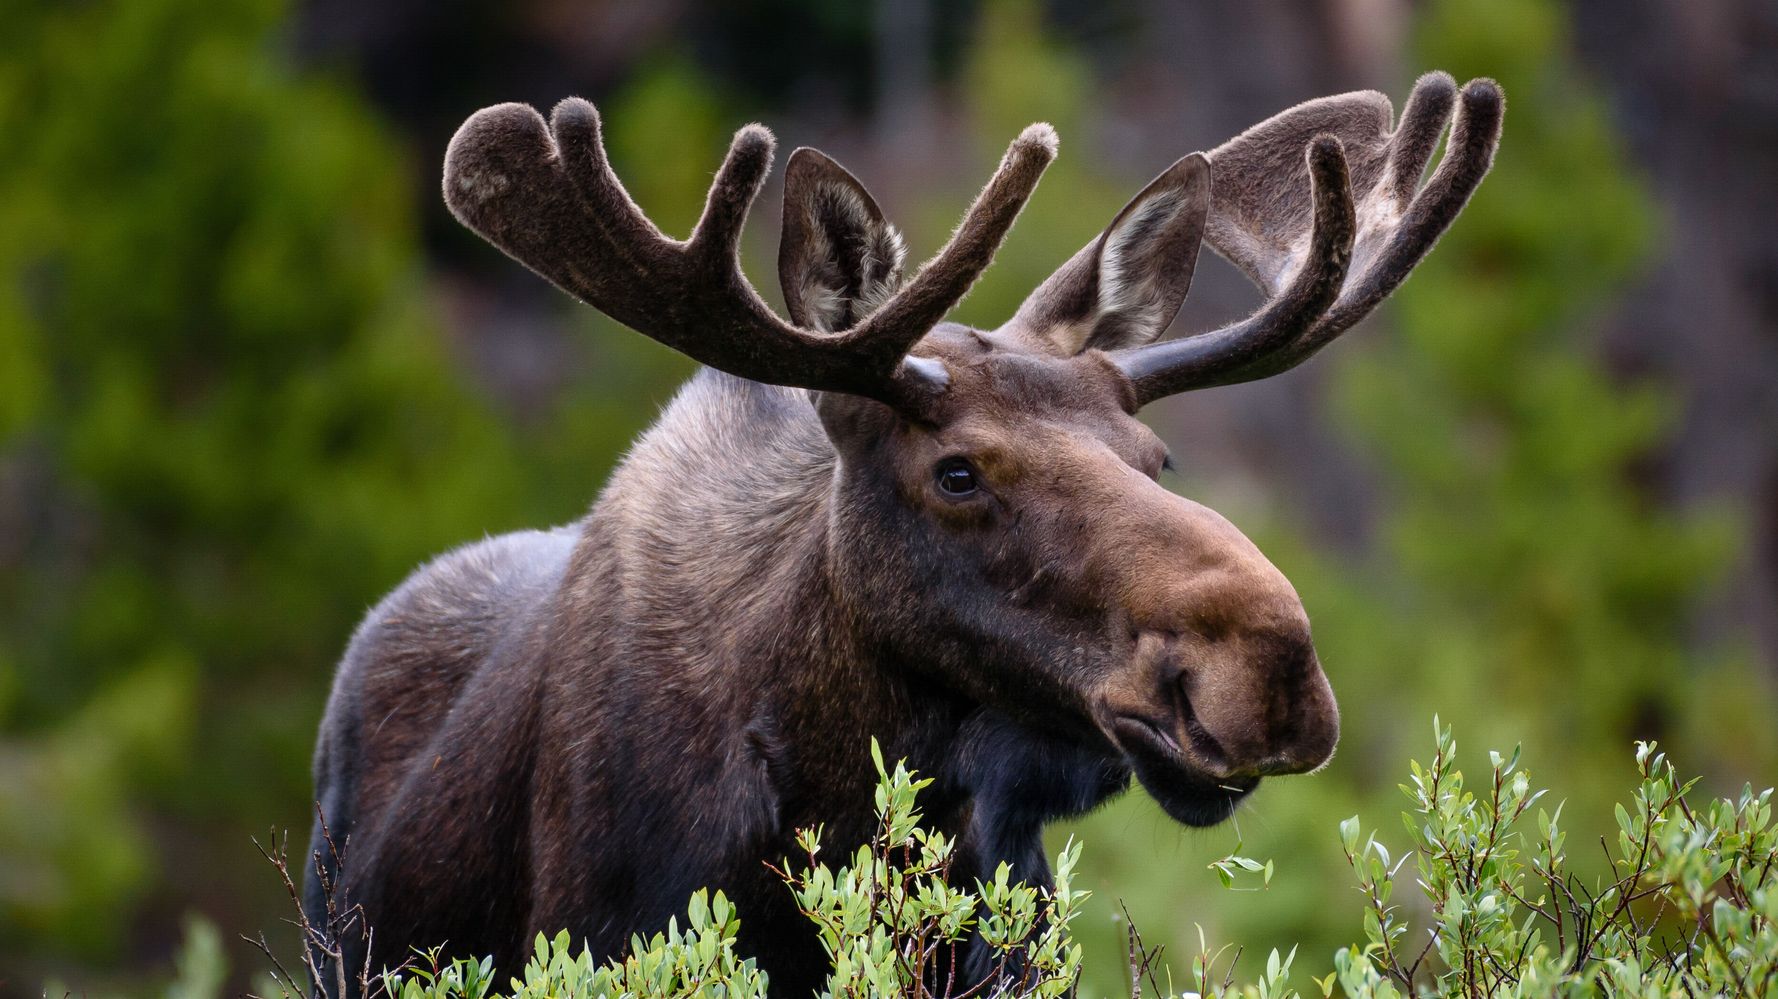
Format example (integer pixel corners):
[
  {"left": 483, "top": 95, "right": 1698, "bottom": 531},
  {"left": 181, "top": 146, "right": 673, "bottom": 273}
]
[{"left": 779, "top": 148, "right": 907, "bottom": 332}]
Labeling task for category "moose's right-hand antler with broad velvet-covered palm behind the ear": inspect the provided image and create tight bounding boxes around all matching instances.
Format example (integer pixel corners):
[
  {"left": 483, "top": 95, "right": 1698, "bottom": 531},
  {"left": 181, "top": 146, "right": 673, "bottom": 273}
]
[{"left": 1109, "top": 73, "right": 1502, "bottom": 404}]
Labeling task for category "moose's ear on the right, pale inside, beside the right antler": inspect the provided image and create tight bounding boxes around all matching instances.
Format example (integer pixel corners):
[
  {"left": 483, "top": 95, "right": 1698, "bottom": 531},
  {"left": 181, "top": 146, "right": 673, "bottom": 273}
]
[{"left": 1013, "top": 153, "right": 1211, "bottom": 354}]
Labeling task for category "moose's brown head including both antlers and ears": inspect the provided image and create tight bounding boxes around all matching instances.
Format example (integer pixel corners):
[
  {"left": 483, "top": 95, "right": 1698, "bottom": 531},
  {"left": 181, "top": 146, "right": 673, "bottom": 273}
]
[{"left": 445, "top": 73, "right": 1502, "bottom": 825}]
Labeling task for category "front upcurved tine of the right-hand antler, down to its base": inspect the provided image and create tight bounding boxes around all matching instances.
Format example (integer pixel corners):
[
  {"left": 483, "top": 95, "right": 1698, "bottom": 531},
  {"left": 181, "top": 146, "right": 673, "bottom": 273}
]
[{"left": 1108, "top": 135, "right": 1357, "bottom": 405}]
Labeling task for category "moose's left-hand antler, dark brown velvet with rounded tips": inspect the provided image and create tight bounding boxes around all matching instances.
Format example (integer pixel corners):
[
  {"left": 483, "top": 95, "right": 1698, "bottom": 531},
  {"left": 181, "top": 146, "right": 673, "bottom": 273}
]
[{"left": 445, "top": 98, "right": 1056, "bottom": 405}]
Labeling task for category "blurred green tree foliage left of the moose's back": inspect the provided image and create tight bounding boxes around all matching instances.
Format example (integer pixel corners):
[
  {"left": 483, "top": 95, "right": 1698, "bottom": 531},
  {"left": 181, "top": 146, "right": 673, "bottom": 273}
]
[{"left": 0, "top": 0, "right": 686, "bottom": 969}]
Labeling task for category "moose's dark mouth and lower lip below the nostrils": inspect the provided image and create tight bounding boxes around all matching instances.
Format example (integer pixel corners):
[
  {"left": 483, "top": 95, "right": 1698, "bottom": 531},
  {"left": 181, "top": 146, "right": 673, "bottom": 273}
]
[{"left": 1109, "top": 706, "right": 1259, "bottom": 827}]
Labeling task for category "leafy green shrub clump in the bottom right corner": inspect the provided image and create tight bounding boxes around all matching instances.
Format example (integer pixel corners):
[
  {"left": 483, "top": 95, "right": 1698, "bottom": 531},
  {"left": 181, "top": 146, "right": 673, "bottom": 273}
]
[{"left": 1323, "top": 720, "right": 1778, "bottom": 999}]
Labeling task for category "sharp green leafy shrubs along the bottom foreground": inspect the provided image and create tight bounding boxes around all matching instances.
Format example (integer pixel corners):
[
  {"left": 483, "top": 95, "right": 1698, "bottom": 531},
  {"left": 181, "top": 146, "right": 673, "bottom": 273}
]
[{"left": 243, "top": 722, "right": 1778, "bottom": 999}]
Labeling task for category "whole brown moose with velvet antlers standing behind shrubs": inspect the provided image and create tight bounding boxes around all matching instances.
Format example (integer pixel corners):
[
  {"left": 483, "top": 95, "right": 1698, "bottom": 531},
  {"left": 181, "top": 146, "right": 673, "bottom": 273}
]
[{"left": 304, "top": 73, "right": 1504, "bottom": 995}]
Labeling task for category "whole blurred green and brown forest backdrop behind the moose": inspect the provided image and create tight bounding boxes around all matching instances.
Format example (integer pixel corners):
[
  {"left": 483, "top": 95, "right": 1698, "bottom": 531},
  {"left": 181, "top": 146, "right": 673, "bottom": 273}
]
[{"left": 0, "top": 0, "right": 1778, "bottom": 995}]
